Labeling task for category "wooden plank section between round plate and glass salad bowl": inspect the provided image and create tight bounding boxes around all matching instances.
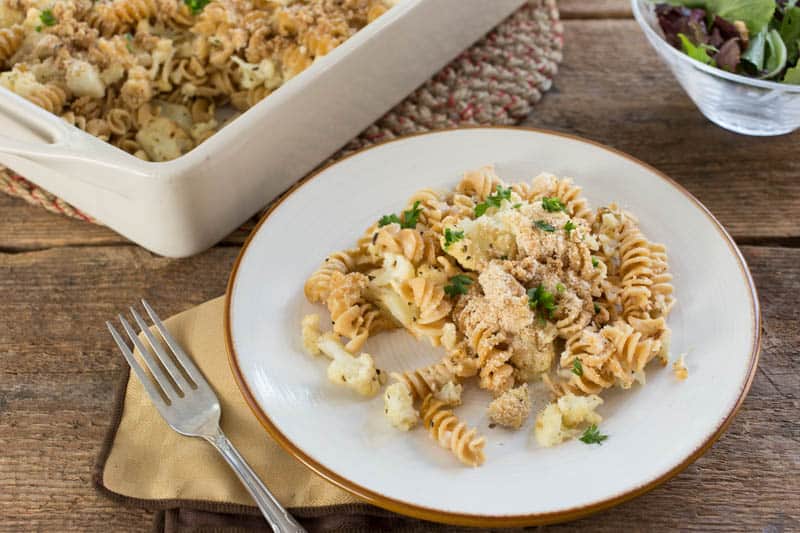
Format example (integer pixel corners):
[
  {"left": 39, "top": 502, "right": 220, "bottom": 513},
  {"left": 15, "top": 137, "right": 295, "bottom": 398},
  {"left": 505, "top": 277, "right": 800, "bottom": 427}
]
[{"left": 526, "top": 20, "right": 800, "bottom": 239}]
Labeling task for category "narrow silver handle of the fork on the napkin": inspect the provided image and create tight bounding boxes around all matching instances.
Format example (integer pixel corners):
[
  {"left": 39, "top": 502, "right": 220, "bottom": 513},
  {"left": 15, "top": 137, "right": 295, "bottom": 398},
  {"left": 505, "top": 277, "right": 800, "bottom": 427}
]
[{"left": 204, "top": 428, "right": 305, "bottom": 533}]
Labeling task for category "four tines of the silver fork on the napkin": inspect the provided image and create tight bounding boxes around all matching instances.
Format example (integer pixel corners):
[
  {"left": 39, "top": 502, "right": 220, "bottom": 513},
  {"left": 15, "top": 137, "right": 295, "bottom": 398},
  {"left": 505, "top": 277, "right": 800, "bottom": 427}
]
[{"left": 106, "top": 300, "right": 207, "bottom": 405}]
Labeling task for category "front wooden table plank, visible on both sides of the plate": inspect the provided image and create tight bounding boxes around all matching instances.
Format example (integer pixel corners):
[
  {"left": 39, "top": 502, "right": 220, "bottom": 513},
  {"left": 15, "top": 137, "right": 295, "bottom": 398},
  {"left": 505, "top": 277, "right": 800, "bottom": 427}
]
[{"left": 0, "top": 246, "right": 800, "bottom": 532}]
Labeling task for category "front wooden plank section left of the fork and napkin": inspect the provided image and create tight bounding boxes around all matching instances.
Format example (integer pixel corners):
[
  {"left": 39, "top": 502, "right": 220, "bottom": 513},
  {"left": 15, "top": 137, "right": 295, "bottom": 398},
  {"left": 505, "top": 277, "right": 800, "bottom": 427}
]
[{"left": 0, "top": 246, "right": 238, "bottom": 532}]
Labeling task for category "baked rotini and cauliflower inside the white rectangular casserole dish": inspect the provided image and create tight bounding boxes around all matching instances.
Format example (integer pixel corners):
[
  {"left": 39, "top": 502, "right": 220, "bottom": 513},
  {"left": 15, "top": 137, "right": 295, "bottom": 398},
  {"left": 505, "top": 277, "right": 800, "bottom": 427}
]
[{"left": 0, "top": 0, "right": 395, "bottom": 161}]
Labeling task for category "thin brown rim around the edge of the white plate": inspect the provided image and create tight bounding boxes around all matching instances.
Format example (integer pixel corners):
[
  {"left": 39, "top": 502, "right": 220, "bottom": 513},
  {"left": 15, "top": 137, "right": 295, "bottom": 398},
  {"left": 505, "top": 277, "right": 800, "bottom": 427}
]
[{"left": 224, "top": 126, "right": 761, "bottom": 527}]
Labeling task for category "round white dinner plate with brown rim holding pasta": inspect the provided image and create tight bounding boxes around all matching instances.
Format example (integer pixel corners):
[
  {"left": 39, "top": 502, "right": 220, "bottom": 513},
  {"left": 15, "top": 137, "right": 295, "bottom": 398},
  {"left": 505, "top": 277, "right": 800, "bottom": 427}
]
[{"left": 225, "top": 128, "right": 760, "bottom": 526}]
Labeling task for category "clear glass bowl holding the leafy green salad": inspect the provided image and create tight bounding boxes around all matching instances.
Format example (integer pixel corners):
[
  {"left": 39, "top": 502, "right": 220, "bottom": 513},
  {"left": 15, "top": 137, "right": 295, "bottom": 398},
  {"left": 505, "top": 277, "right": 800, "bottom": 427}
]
[{"left": 631, "top": 0, "right": 800, "bottom": 136}]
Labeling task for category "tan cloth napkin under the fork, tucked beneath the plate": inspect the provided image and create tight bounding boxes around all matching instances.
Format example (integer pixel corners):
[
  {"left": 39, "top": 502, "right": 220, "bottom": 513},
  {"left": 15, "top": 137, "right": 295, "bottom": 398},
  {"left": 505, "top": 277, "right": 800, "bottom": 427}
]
[{"left": 102, "top": 298, "right": 360, "bottom": 507}]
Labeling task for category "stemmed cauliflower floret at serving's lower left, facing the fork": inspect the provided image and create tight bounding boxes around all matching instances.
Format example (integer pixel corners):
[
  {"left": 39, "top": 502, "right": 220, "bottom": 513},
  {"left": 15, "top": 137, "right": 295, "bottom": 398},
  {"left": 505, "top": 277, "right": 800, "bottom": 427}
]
[{"left": 317, "top": 333, "right": 382, "bottom": 396}]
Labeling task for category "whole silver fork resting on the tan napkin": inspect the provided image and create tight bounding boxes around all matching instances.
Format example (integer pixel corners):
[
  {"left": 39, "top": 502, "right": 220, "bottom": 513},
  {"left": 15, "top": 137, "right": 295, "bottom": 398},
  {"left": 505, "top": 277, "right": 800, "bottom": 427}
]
[{"left": 106, "top": 300, "right": 305, "bottom": 532}]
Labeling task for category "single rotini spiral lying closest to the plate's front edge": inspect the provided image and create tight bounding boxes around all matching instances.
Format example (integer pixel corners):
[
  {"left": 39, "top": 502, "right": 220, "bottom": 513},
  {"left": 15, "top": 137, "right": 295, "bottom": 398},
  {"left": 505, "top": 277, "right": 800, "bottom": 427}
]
[{"left": 421, "top": 395, "right": 486, "bottom": 466}]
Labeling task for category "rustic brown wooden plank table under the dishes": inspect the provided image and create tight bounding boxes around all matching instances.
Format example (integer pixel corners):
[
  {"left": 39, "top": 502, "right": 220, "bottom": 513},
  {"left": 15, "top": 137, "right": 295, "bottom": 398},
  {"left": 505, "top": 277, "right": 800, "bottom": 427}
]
[{"left": 0, "top": 0, "right": 800, "bottom": 532}]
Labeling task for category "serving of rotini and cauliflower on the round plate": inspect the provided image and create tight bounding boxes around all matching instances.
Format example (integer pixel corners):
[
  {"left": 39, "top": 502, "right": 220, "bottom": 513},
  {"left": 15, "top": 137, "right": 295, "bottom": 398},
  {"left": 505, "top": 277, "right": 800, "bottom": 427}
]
[{"left": 302, "top": 167, "right": 686, "bottom": 466}]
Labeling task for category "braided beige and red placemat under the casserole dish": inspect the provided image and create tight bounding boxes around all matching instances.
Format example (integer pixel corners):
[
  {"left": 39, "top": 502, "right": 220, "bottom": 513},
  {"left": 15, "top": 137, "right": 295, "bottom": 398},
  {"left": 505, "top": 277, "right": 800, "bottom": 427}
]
[{"left": 0, "top": 0, "right": 564, "bottom": 224}]
